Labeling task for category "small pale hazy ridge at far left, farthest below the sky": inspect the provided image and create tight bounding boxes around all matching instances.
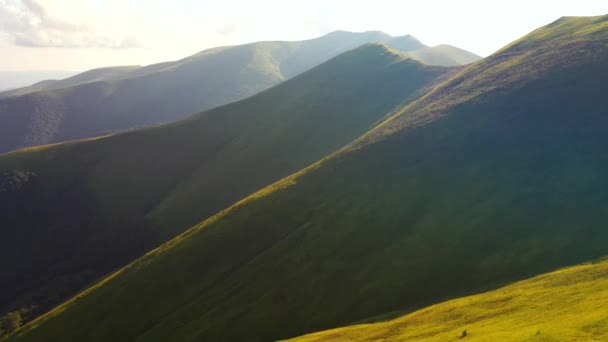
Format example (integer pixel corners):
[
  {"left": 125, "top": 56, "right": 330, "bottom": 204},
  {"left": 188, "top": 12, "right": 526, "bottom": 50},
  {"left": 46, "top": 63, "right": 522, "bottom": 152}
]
[{"left": 0, "top": 66, "right": 140, "bottom": 99}]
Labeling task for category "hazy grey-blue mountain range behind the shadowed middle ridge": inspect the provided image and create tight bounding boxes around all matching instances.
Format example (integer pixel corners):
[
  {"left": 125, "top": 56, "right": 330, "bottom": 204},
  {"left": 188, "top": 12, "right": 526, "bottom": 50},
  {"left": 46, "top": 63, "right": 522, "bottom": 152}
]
[{"left": 0, "top": 31, "right": 480, "bottom": 153}]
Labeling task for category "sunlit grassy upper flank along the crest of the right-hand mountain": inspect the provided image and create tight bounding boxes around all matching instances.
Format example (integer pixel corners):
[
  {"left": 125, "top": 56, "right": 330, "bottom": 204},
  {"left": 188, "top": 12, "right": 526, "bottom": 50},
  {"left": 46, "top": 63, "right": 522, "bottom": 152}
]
[{"left": 361, "top": 16, "right": 608, "bottom": 143}]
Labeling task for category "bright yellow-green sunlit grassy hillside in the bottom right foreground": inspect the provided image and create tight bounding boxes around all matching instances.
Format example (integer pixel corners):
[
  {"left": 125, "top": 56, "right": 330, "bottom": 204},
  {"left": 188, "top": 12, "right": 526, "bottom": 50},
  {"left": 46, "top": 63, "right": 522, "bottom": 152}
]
[{"left": 290, "top": 261, "right": 608, "bottom": 342}]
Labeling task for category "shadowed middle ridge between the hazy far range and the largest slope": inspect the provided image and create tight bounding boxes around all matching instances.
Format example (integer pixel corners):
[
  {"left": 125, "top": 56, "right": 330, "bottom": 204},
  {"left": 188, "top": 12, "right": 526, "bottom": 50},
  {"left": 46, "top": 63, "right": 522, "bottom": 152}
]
[{"left": 0, "top": 45, "right": 456, "bottom": 330}]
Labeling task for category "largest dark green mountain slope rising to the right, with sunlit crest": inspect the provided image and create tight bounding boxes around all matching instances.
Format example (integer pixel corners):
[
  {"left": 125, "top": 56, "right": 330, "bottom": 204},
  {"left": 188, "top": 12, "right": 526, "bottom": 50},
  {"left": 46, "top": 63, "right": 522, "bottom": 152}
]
[{"left": 4, "top": 16, "right": 608, "bottom": 341}]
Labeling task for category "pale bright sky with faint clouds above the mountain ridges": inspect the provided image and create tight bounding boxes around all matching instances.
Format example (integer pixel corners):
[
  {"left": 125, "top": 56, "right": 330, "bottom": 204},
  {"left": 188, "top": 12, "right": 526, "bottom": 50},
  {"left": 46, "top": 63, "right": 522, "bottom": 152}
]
[{"left": 0, "top": 0, "right": 608, "bottom": 71}]
